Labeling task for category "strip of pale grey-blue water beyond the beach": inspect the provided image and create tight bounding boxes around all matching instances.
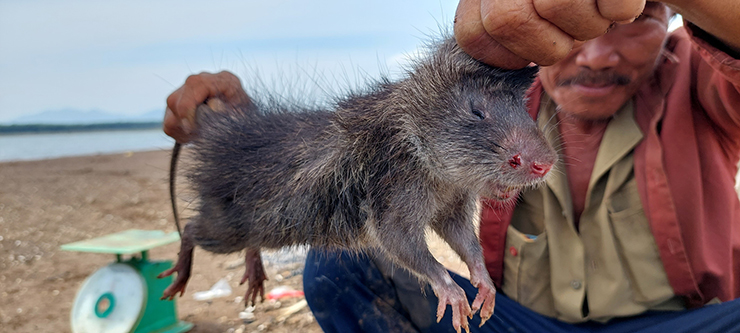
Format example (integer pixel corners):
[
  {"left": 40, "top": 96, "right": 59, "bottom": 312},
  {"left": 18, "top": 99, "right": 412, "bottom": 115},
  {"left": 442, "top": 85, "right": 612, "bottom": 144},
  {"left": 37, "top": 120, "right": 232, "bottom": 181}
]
[{"left": 0, "top": 129, "right": 175, "bottom": 162}]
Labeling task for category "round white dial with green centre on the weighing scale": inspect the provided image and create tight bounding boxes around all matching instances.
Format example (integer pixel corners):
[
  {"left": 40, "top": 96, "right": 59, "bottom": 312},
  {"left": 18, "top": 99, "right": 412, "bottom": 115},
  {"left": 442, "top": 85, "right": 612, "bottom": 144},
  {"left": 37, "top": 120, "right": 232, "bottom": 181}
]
[{"left": 71, "top": 263, "right": 146, "bottom": 333}]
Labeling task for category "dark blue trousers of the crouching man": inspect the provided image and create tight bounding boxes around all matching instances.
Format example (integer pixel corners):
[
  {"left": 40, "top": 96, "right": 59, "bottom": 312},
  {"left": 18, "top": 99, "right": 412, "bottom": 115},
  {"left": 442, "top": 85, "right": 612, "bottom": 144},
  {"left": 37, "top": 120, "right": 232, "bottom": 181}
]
[{"left": 303, "top": 250, "right": 740, "bottom": 333}]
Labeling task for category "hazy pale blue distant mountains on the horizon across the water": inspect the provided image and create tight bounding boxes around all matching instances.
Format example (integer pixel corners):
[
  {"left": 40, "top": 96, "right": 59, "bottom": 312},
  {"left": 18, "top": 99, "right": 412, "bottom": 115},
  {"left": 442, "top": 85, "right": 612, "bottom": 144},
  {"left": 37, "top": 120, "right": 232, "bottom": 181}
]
[{"left": 4, "top": 109, "right": 164, "bottom": 125}]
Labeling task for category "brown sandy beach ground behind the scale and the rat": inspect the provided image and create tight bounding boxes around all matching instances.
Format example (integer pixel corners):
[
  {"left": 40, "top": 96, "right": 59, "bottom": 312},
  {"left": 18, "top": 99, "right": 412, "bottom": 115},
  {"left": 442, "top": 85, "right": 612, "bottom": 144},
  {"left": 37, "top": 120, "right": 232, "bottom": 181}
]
[{"left": 0, "top": 151, "right": 462, "bottom": 333}]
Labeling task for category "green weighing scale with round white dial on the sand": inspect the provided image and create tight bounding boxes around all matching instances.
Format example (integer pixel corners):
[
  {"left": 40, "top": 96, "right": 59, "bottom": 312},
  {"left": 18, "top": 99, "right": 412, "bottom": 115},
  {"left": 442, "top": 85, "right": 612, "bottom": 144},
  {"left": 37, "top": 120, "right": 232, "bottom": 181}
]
[{"left": 62, "top": 229, "right": 193, "bottom": 333}]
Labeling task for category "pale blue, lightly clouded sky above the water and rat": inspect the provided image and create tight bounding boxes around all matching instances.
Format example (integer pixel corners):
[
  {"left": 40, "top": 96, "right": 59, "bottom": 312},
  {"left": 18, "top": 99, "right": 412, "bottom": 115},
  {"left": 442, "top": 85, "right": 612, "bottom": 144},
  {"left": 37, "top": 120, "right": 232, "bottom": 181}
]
[{"left": 0, "top": 0, "right": 457, "bottom": 123}]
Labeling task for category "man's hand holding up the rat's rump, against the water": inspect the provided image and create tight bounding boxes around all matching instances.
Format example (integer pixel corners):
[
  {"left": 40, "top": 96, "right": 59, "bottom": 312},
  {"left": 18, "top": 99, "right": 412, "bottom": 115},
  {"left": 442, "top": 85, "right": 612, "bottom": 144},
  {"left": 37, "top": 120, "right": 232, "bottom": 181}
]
[{"left": 163, "top": 71, "right": 249, "bottom": 143}]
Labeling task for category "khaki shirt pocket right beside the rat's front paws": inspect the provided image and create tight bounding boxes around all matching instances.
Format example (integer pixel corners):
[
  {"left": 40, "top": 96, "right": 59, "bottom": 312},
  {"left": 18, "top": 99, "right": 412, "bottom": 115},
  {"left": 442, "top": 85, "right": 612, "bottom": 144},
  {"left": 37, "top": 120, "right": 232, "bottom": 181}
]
[{"left": 502, "top": 226, "right": 557, "bottom": 317}]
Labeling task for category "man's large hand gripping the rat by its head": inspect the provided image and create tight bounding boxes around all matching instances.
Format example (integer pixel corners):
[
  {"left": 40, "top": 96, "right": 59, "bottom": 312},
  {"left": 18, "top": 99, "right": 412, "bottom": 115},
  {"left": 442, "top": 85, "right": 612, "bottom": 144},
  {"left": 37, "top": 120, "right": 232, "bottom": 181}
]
[{"left": 455, "top": 0, "right": 645, "bottom": 69}]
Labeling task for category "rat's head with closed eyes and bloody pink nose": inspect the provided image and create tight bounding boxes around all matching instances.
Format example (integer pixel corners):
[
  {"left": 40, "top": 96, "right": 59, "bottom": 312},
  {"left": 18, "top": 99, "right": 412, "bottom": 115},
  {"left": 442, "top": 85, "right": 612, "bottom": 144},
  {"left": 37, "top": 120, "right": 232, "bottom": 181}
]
[{"left": 404, "top": 41, "right": 557, "bottom": 200}]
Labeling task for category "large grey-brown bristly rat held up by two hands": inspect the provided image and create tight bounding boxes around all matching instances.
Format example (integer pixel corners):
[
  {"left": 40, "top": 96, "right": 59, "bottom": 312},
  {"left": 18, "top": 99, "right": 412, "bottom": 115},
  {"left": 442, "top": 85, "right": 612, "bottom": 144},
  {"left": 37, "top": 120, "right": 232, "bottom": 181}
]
[{"left": 162, "top": 38, "right": 557, "bottom": 331}]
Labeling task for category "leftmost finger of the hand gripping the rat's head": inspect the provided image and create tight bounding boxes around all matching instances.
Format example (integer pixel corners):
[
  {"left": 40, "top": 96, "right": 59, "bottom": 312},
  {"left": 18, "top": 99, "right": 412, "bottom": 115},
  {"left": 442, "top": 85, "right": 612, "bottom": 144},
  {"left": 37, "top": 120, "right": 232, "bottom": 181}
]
[{"left": 454, "top": 0, "right": 530, "bottom": 69}]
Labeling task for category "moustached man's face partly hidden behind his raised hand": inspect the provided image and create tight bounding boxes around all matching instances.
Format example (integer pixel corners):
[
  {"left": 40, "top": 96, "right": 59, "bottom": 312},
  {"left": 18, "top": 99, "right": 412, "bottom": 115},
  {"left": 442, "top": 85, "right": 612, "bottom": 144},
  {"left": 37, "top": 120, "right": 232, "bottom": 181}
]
[{"left": 540, "top": 2, "right": 669, "bottom": 120}]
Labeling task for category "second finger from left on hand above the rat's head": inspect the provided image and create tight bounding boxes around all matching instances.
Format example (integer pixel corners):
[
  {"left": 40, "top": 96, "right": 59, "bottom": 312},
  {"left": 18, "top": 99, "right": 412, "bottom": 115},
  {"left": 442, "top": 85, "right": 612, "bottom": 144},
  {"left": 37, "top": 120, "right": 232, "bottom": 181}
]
[{"left": 481, "top": 0, "right": 573, "bottom": 66}]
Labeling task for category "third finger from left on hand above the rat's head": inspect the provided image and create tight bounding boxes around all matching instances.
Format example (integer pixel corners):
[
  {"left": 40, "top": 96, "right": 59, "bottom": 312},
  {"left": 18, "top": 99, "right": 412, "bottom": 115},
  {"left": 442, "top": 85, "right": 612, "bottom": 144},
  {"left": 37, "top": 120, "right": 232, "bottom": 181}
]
[{"left": 532, "top": 0, "right": 613, "bottom": 40}]
